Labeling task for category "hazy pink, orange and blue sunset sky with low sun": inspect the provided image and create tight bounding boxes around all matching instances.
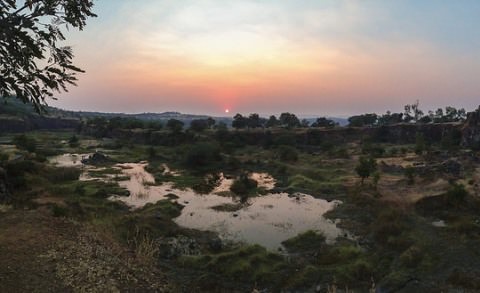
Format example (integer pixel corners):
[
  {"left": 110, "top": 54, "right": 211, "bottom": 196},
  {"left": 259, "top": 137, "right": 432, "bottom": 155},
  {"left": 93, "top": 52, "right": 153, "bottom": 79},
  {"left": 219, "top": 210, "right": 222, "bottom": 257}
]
[{"left": 50, "top": 0, "right": 480, "bottom": 117}]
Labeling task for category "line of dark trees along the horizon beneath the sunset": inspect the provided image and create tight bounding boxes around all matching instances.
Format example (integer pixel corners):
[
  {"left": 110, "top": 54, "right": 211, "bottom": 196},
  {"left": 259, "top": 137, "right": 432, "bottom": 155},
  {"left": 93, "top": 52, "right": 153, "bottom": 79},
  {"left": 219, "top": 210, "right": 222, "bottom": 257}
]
[{"left": 81, "top": 102, "right": 467, "bottom": 132}]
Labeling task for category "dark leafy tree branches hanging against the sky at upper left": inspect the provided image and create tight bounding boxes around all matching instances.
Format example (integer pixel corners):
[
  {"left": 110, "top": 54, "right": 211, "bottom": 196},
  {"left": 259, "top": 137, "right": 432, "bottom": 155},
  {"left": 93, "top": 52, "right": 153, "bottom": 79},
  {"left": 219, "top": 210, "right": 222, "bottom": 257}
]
[{"left": 0, "top": 0, "right": 96, "bottom": 112}]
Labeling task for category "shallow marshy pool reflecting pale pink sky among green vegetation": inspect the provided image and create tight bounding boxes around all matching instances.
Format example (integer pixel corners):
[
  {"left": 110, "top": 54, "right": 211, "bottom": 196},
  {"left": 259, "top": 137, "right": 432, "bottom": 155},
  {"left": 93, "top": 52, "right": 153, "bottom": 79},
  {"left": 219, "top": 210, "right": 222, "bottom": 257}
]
[{"left": 50, "top": 155, "right": 347, "bottom": 250}]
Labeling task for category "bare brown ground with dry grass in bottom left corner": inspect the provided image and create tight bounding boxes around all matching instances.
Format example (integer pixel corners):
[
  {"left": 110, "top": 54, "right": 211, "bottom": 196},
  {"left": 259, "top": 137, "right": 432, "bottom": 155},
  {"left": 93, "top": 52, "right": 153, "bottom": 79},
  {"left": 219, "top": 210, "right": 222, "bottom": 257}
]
[{"left": 0, "top": 207, "right": 169, "bottom": 292}]
